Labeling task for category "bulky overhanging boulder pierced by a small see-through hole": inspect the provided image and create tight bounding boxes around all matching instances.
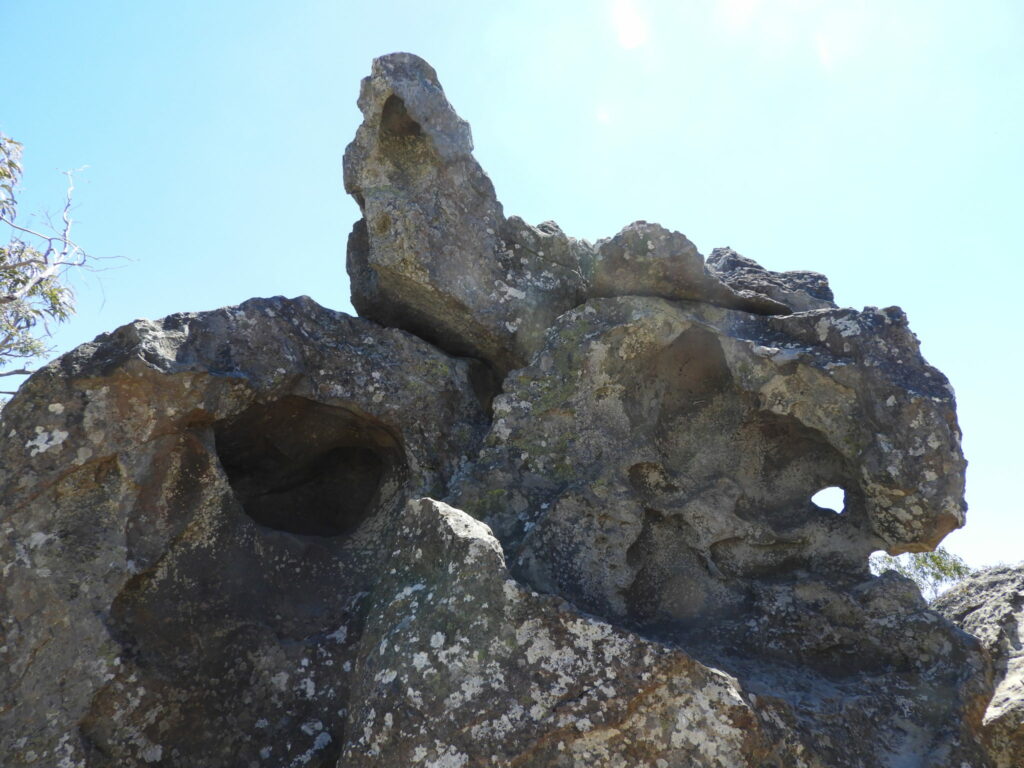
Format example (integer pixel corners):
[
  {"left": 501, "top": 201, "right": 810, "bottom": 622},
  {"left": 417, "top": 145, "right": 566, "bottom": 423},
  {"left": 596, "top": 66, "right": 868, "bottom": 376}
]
[{"left": 457, "top": 297, "right": 966, "bottom": 569}]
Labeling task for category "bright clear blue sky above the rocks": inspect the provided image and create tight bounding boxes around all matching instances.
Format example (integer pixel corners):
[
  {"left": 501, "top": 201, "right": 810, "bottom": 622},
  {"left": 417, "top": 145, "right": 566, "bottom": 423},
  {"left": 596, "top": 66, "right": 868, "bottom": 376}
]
[{"left": 0, "top": 0, "right": 1024, "bottom": 565}]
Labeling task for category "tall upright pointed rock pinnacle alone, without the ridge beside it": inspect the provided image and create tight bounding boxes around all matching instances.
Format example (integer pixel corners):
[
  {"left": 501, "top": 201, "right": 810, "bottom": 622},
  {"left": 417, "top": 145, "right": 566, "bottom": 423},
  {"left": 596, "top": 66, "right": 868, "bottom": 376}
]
[{"left": 344, "top": 53, "right": 518, "bottom": 372}]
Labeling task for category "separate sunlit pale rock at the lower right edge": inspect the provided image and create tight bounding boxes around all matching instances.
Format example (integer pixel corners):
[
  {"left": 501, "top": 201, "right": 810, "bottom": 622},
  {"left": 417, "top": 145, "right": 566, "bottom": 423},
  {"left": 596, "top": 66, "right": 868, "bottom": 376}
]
[{"left": 934, "top": 565, "right": 1024, "bottom": 768}]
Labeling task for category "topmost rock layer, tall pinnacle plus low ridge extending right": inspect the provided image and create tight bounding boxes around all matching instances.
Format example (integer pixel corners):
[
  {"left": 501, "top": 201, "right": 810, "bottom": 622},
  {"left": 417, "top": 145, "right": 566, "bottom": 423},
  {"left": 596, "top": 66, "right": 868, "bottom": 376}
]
[{"left": 344, "top": 53, "right": 791, "bottom": 376}]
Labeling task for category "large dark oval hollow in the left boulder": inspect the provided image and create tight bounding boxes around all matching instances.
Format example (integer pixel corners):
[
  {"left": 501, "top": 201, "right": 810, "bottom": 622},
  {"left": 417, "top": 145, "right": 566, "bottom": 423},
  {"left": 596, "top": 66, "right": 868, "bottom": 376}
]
[{"left": 214, "top": 396, "right": 404, "bottom": 537}]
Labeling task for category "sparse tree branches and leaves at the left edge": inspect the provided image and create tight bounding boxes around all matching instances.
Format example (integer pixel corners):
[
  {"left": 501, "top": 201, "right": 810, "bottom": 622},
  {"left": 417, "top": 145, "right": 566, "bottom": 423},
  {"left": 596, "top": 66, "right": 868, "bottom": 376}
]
[{"left": 0, "top": 133, "right": 84, "bottom": 394}]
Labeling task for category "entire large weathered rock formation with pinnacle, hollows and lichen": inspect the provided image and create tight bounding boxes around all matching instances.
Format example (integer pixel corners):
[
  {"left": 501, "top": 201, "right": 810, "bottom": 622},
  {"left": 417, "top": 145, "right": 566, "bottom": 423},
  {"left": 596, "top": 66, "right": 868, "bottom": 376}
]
[{"left": 0, "top": 54, "right": 991, "bottom": 768}]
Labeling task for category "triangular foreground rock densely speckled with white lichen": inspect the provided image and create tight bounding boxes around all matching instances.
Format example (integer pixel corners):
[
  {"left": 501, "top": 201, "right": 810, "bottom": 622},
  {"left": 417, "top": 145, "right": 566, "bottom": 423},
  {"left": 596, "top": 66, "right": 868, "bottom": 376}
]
[{"left": 339, "top": 499, "right": 790, "bottom": 768}]
